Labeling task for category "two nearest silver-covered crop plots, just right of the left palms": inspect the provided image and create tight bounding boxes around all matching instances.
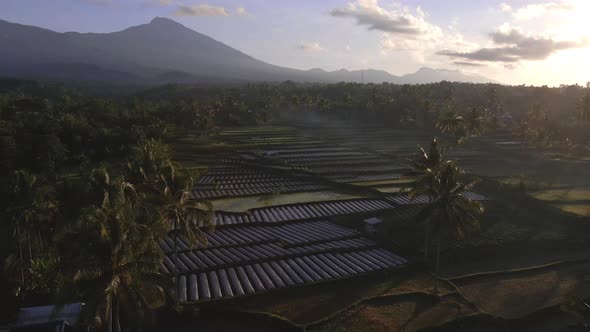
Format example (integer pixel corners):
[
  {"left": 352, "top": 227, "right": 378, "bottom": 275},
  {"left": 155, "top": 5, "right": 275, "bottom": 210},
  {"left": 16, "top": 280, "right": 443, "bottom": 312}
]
[{"left": 161, "top": 221, "right": 406, "bottom": 302}]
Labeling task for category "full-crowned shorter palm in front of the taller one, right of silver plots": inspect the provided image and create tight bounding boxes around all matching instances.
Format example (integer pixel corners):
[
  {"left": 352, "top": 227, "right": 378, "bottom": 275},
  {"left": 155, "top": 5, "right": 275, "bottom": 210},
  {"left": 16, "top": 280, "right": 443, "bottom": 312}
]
[{"left": 419, "top": 161, "right": 484, "bottom": 292}]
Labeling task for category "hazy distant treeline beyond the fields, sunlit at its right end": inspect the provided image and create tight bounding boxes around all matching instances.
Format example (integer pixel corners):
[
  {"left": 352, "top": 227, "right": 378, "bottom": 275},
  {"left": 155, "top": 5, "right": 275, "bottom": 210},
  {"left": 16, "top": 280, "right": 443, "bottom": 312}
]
[{"left": 136, "top": 82, "right": 590, "bottom": 148}]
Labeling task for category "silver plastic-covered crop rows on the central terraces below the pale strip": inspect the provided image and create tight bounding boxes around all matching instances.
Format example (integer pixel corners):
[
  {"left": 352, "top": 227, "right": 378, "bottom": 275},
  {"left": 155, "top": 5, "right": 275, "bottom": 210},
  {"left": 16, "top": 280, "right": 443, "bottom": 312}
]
[{"left": 161, "top": 193, "right": 485, "bottom": 303}]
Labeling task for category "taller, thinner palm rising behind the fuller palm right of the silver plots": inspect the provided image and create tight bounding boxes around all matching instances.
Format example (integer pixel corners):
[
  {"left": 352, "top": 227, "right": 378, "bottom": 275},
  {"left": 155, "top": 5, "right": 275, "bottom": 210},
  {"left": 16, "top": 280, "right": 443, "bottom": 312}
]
[{"left": 408, "top": 138, "right": 443, "bottom": 263}]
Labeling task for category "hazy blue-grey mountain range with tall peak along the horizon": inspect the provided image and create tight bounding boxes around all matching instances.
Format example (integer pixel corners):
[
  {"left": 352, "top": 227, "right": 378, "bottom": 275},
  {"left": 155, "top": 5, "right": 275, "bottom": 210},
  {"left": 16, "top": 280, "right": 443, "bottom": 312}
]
[{"left": 0, "top": 18, "right": 500, "bottom": 84}]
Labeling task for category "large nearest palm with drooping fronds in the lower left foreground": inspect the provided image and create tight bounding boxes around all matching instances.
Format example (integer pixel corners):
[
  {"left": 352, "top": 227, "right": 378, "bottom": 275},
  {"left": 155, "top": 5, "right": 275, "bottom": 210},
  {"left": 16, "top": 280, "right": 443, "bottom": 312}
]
[{"left": 62, "top": 172, "right": 172, "bottom": 332}]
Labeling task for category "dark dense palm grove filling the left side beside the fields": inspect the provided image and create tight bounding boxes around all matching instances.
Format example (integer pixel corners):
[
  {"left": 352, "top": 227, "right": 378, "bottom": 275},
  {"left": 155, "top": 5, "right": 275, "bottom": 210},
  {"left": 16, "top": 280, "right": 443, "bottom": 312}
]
[{"left": 0, "top": 81, "right": 224, "bottom": 331}]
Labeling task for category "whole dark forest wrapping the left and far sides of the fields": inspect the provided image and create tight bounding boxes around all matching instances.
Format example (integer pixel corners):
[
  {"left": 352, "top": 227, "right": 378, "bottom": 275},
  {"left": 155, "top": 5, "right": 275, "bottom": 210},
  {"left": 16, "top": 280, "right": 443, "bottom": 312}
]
[{"left": 0, "top": 79, "right": 590, "bottom": 330}]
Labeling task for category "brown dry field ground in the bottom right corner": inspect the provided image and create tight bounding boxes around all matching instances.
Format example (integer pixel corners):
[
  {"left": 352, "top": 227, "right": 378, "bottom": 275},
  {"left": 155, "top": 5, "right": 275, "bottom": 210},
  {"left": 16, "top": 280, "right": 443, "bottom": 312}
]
[{"left": 312, "top": 263, "right": 590, "bottom": 331}]
